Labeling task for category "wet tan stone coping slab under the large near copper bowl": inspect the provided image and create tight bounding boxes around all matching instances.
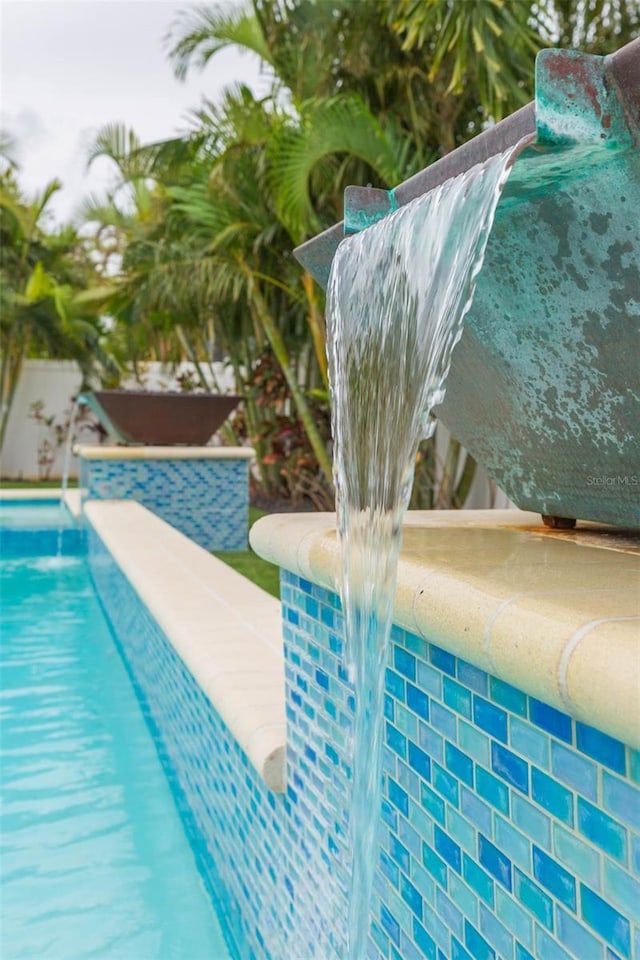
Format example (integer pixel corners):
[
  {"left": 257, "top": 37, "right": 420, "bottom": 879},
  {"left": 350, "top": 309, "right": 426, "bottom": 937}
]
[{"left": 250, "top": 510, "right": 640, "bottom": 748}]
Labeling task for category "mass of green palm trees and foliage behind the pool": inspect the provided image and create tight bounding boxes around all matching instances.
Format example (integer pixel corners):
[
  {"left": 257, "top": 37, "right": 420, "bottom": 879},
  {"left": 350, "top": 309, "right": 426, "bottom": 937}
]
[{"left": 13, "top": 0, "right": 640, "bottom": 506}]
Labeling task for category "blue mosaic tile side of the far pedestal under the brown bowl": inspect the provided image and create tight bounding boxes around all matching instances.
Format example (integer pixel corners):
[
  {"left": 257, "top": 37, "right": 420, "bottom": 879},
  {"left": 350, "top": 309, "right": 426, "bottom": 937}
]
[{"left": 80, "top": 457, "right": 249, "bottom": 551}]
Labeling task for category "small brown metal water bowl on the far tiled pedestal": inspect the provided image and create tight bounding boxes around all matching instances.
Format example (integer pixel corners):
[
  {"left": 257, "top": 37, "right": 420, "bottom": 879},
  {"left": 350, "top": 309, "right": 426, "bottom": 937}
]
[{"left": 78, "top": 390, "right": 242, "bottom": 447}]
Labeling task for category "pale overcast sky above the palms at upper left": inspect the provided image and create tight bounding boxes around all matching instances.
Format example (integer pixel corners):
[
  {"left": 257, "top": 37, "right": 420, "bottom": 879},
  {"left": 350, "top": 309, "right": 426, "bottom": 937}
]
[{"left": 0, "top": 0, "right": 267, "bottom": 219}]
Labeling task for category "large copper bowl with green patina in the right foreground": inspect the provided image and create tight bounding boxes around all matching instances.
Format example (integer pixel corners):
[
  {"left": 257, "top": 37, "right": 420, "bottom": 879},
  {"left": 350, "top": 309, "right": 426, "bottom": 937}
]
[{"left": 296, "top": 41, "right": 640, "bottom": 526}]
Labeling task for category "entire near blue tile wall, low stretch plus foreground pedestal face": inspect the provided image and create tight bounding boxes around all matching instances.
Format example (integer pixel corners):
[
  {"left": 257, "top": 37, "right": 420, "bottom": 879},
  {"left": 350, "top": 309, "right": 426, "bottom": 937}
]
[{"left": 90, "top": 516, "right": 640, "bottom": 960}]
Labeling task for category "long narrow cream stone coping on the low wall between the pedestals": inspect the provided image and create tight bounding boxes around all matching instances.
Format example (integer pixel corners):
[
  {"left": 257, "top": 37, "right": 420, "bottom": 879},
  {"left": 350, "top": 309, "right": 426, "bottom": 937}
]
[{"left": 84, "top": 500, "right": 286, "bottom": 793}]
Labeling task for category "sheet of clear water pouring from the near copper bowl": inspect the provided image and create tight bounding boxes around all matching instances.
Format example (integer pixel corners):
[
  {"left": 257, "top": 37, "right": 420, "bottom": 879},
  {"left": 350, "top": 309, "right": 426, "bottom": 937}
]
[{"left": 327, "top": 148, "right": 517, "bottom": 960}]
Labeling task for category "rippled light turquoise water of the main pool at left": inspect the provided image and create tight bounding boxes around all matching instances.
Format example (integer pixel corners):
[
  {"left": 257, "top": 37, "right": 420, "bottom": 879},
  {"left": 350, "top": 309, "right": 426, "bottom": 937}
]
[{"left": 0, "top": 532, "right": 229, "bottom": 960}]
